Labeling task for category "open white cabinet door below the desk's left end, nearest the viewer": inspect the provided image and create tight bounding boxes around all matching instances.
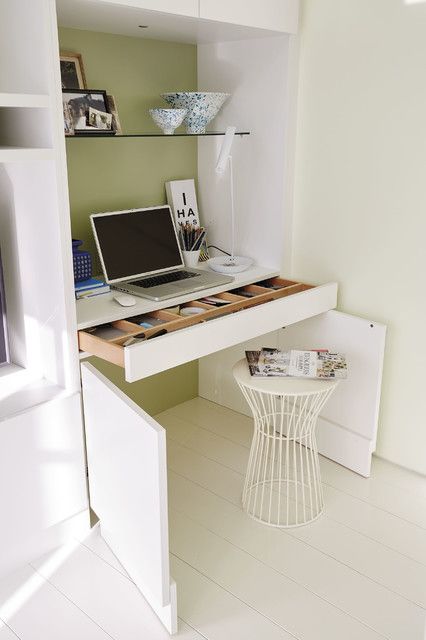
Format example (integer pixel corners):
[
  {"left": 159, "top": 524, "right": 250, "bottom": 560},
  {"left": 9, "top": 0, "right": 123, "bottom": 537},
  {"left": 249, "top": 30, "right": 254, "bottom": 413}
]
[{"left": 81, "top": 363, "right": 177, "bottom": 633}]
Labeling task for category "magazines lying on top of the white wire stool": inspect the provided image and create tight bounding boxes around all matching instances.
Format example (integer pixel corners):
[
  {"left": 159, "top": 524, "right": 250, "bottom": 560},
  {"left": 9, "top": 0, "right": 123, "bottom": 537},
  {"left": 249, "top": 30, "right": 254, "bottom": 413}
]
[{"left": 246, "top": 347, "right": 348, "bottom": 380}]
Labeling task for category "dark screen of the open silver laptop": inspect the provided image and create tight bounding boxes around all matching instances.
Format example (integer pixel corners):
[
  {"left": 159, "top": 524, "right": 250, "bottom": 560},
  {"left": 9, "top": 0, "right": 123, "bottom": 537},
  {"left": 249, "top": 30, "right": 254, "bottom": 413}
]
[{"left": 90, "top": 206, "right": 183, "bottom": 283}]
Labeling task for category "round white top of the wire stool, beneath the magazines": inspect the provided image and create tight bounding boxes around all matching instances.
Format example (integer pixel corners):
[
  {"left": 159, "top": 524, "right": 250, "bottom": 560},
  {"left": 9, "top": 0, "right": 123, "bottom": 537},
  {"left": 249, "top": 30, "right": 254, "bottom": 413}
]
[{"left": 232, "top": 358, "right": 339, "bottom": 396}]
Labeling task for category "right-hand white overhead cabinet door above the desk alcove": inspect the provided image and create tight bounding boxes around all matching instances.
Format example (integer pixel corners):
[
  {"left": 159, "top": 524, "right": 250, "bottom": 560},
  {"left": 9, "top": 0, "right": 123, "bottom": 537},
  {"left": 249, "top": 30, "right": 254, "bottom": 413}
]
[{"left": 200, "top": 0, "right": 299, "bottom": 33}]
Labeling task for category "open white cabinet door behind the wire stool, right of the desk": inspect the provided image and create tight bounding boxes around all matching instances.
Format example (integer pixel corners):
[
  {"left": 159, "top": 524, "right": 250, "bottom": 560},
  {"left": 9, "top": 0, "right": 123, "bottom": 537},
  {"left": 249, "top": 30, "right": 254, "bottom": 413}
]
[{"left": 279, "top": 311, "right": 386, "bottom": 477}]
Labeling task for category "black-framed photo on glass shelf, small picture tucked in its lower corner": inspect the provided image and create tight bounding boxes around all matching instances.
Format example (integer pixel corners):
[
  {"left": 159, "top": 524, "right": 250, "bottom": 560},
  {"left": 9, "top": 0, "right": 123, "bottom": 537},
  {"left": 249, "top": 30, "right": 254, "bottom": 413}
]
[{"left": 62, "top": 89, "right": 115, "bottom": 135}]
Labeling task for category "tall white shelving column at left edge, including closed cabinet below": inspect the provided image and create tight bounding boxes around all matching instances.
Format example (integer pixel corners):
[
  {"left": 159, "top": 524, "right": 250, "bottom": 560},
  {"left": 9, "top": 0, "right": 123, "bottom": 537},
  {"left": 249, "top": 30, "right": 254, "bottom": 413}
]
[{"left": 0, "top": 0, "right": 88, "bottom": 575}]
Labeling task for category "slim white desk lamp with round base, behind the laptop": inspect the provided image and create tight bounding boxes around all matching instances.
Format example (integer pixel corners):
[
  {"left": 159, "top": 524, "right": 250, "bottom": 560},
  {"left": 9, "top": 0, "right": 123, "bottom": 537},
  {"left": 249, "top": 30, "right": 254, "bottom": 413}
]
[{"left": 208, "top": 127, "right": 253, "bottom": 274}]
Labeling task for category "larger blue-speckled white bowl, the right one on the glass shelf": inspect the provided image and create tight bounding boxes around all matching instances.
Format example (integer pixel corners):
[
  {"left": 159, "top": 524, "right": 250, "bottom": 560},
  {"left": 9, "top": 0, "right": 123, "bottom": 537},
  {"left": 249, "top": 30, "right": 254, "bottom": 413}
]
[{"left": 161, "top": 91, "right": 231, "bottom": 133}]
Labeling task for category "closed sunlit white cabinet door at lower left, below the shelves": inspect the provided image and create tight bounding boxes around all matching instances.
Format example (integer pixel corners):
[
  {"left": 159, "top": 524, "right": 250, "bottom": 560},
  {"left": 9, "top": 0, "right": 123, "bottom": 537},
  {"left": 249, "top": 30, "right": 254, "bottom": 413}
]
[{"left": 0, "top": 390, "right": 89, "bottom": 580}]
